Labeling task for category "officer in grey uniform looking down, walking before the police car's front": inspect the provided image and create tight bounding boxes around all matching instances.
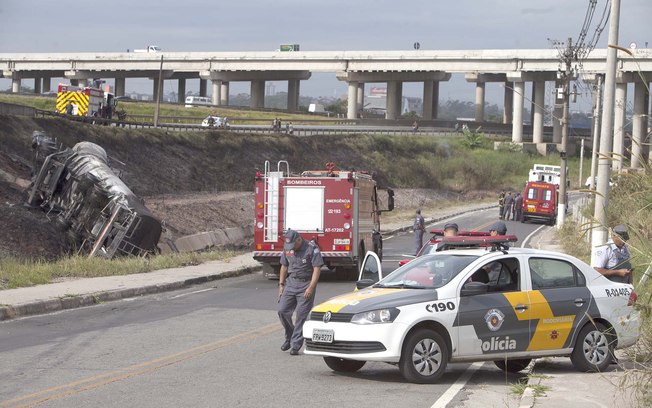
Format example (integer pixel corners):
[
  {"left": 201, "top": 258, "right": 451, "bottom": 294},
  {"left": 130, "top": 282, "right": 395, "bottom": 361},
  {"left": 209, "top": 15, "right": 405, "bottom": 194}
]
[{"left": 278, "top": 230, "right": 324, "bottom": 356}]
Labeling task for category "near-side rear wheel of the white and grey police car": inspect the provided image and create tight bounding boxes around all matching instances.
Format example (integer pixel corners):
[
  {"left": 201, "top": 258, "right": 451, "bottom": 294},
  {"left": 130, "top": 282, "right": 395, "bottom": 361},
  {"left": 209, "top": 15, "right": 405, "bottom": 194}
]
[{"left": 571, "top": 323, "right": 615, "bottom": 372}]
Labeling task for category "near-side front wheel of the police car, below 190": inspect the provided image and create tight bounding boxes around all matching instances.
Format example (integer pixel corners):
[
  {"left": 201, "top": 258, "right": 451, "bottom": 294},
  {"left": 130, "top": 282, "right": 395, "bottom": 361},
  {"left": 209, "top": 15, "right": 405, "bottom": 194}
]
[{"left": 398, "top": 329, "right": 448, "bottom": 384}]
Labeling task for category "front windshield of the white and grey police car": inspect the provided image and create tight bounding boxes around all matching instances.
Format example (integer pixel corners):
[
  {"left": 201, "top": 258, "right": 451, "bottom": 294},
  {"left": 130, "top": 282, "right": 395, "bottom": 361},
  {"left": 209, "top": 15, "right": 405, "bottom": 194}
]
[{"left": 375, "top": 252, "right": 478, "bottom": 289}]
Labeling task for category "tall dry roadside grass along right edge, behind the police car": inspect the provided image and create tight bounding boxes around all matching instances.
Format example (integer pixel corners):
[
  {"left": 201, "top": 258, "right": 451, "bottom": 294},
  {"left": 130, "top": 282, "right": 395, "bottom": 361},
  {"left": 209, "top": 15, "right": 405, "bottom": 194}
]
[{"left": 559, "top": 168, "right": 652, "bottom": 407}]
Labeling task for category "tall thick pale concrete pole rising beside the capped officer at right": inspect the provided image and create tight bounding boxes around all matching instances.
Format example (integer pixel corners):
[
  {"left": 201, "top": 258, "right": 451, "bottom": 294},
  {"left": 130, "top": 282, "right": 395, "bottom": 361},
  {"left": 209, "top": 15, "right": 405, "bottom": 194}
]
[{"left": 591, "top": 0, "right": 620, "bottom": 262}]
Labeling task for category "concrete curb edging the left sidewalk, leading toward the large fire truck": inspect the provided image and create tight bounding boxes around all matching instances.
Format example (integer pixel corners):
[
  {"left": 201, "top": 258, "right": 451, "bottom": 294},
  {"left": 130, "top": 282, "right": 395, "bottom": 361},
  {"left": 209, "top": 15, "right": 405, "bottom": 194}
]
[{"left": 0, "top": 266, "right": 262, "bottom": 321}]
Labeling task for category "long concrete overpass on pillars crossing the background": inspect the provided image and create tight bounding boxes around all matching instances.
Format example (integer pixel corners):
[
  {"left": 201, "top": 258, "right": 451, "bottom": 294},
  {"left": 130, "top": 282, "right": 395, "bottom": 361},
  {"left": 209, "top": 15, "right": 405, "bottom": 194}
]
[{"left": 0, "top": 49, "right": 652, "bottom": 155}]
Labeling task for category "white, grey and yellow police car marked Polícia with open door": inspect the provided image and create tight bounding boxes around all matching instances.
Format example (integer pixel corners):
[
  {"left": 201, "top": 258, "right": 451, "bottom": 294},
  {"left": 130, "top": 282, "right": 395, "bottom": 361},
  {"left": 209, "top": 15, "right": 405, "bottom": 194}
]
[{"left": 303, "top": 237, "right": 640, "bottom": 383}]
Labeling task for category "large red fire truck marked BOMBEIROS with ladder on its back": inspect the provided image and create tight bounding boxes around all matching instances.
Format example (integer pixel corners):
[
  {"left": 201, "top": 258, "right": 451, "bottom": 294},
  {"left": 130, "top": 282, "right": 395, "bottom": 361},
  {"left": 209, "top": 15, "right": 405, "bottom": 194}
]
[{"left": 253, "top": 160, "right": 394, "bottom": 280}]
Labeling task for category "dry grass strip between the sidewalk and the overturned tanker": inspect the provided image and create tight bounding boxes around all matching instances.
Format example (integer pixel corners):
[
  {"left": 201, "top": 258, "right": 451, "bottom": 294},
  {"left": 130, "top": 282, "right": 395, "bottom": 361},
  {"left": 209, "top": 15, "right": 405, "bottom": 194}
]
[{"left": 0, "top": 250, "right": 237, "bottom": 289}]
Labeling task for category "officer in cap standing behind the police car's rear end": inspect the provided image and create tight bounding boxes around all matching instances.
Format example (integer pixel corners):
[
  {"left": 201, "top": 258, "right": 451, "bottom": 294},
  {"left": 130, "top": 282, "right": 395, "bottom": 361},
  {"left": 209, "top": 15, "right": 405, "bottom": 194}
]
[{"left": 593, "top": 224, "right": 632, "bottom": 283}]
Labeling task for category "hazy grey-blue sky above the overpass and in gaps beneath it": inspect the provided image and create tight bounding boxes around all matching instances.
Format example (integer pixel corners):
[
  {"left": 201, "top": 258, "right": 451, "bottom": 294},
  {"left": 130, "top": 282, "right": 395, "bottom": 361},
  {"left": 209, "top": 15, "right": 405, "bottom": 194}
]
[{"left": 0, "top": 0, "right": 652, "bottom": 105}]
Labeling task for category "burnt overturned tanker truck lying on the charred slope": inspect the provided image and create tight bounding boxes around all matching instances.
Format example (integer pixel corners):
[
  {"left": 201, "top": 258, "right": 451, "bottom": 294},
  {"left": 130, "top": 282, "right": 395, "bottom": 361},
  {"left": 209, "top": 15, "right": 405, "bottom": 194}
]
[{"left": 27, "top": 131, "right": 161, "bottom": 259}]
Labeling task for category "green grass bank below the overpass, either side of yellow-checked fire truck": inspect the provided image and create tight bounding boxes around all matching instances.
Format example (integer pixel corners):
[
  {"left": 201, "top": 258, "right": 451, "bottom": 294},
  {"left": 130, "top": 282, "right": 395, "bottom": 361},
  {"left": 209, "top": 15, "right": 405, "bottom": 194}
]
[{"left": 0, "top": 93, "right": 328, "bottom": 125}]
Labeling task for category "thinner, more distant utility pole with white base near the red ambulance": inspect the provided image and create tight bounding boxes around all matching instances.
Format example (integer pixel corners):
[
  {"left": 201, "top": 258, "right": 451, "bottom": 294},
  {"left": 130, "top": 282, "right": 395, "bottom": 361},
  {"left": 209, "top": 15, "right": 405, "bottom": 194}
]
[{"left": 557, "top": 38, "right": 575, "bottom": 228}]
